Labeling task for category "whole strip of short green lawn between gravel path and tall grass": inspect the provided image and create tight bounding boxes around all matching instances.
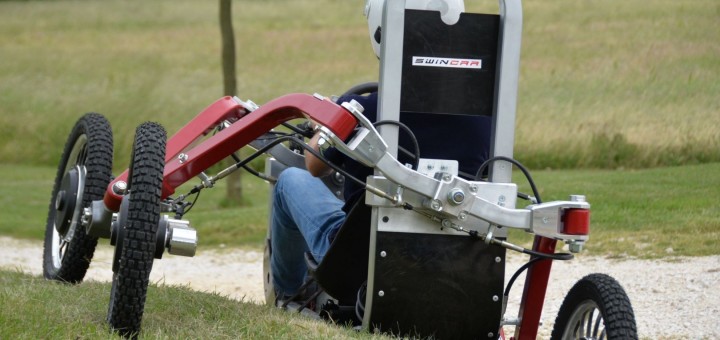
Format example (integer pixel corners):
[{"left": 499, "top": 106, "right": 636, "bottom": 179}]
[{"left": 0, "top": 163, "right": 720, "bottom": 257}]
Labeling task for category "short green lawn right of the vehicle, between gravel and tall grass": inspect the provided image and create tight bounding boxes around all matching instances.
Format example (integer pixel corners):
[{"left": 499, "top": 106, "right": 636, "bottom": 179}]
[{"left": 514, "top": 163, "right": 720, "bottom": 257}]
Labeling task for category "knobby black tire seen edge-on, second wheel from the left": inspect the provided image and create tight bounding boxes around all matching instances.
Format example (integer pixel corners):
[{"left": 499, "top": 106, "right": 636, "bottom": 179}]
[{"left": 107, "top": 123, "right": 167, "bottom": 337}]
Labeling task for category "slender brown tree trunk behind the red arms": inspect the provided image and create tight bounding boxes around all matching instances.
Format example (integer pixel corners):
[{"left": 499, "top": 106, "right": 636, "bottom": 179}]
[{"left": 220, "top": 0, "right": 242, "bottom": 203}]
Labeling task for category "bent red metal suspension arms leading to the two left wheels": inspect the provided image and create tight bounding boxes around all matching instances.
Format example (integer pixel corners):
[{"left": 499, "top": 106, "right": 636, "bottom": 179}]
[{"left": 103, "top": 94, "right": 357, "bottom": 211}]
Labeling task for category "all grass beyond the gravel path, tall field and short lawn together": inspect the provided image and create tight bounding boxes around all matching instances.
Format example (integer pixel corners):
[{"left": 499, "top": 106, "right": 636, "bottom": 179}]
[{"left": 0, "top": 0, "right": 720, "bottom": 256}]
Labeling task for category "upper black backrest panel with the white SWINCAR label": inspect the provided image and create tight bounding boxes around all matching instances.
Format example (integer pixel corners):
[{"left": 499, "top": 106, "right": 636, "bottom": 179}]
[{"left": 400, "top": 10, "right": 500, "bottom": 116}]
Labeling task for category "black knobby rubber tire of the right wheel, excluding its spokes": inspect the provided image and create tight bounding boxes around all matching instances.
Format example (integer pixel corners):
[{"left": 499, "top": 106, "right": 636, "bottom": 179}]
[{"left": 550, "top": 273, "right": 638, "bottom": 340}]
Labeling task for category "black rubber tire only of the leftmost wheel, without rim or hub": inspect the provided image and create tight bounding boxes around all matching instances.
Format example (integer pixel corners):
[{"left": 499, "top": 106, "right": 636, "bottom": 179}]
[{"left": 43, "top": 112, "right": 113, "bottom": 283}]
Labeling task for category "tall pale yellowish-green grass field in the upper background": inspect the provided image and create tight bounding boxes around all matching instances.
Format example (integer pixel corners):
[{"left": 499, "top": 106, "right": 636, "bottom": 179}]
[{"left": 0, "top": 0, "right": 720, "bottom": 168}]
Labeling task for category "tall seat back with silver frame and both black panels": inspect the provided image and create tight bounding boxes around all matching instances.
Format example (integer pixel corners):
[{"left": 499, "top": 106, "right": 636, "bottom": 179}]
[{"left": 363, "top": 0, "right": 522, "bottom": 338}]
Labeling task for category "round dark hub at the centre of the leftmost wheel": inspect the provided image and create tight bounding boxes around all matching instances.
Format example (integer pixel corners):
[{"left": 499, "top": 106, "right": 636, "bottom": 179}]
[{"left": 55, "top": 165, "right": 85, "bottom": 237}]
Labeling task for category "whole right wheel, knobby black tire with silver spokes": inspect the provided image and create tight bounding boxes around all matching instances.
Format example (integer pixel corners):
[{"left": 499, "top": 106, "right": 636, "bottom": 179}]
[{"left": 551, "top": 274, "right": 638, "bottom": 340}]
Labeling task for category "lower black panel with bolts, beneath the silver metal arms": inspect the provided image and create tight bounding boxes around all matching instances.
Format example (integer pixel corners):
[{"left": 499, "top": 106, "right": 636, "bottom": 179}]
[{"left": 368, "top": 232, "right": 505, "bottom": 339}]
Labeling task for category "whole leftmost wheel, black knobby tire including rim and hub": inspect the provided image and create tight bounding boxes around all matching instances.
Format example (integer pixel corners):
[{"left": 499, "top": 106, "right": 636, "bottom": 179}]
[{"left": 43, "top": 113, "right": 113, "bottom": 283}]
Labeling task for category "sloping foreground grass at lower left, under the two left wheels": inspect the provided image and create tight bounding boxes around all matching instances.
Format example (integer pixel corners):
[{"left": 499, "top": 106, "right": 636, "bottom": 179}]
[{"left": 0, "top": 270, "right": 384, "bottom": 339}]
